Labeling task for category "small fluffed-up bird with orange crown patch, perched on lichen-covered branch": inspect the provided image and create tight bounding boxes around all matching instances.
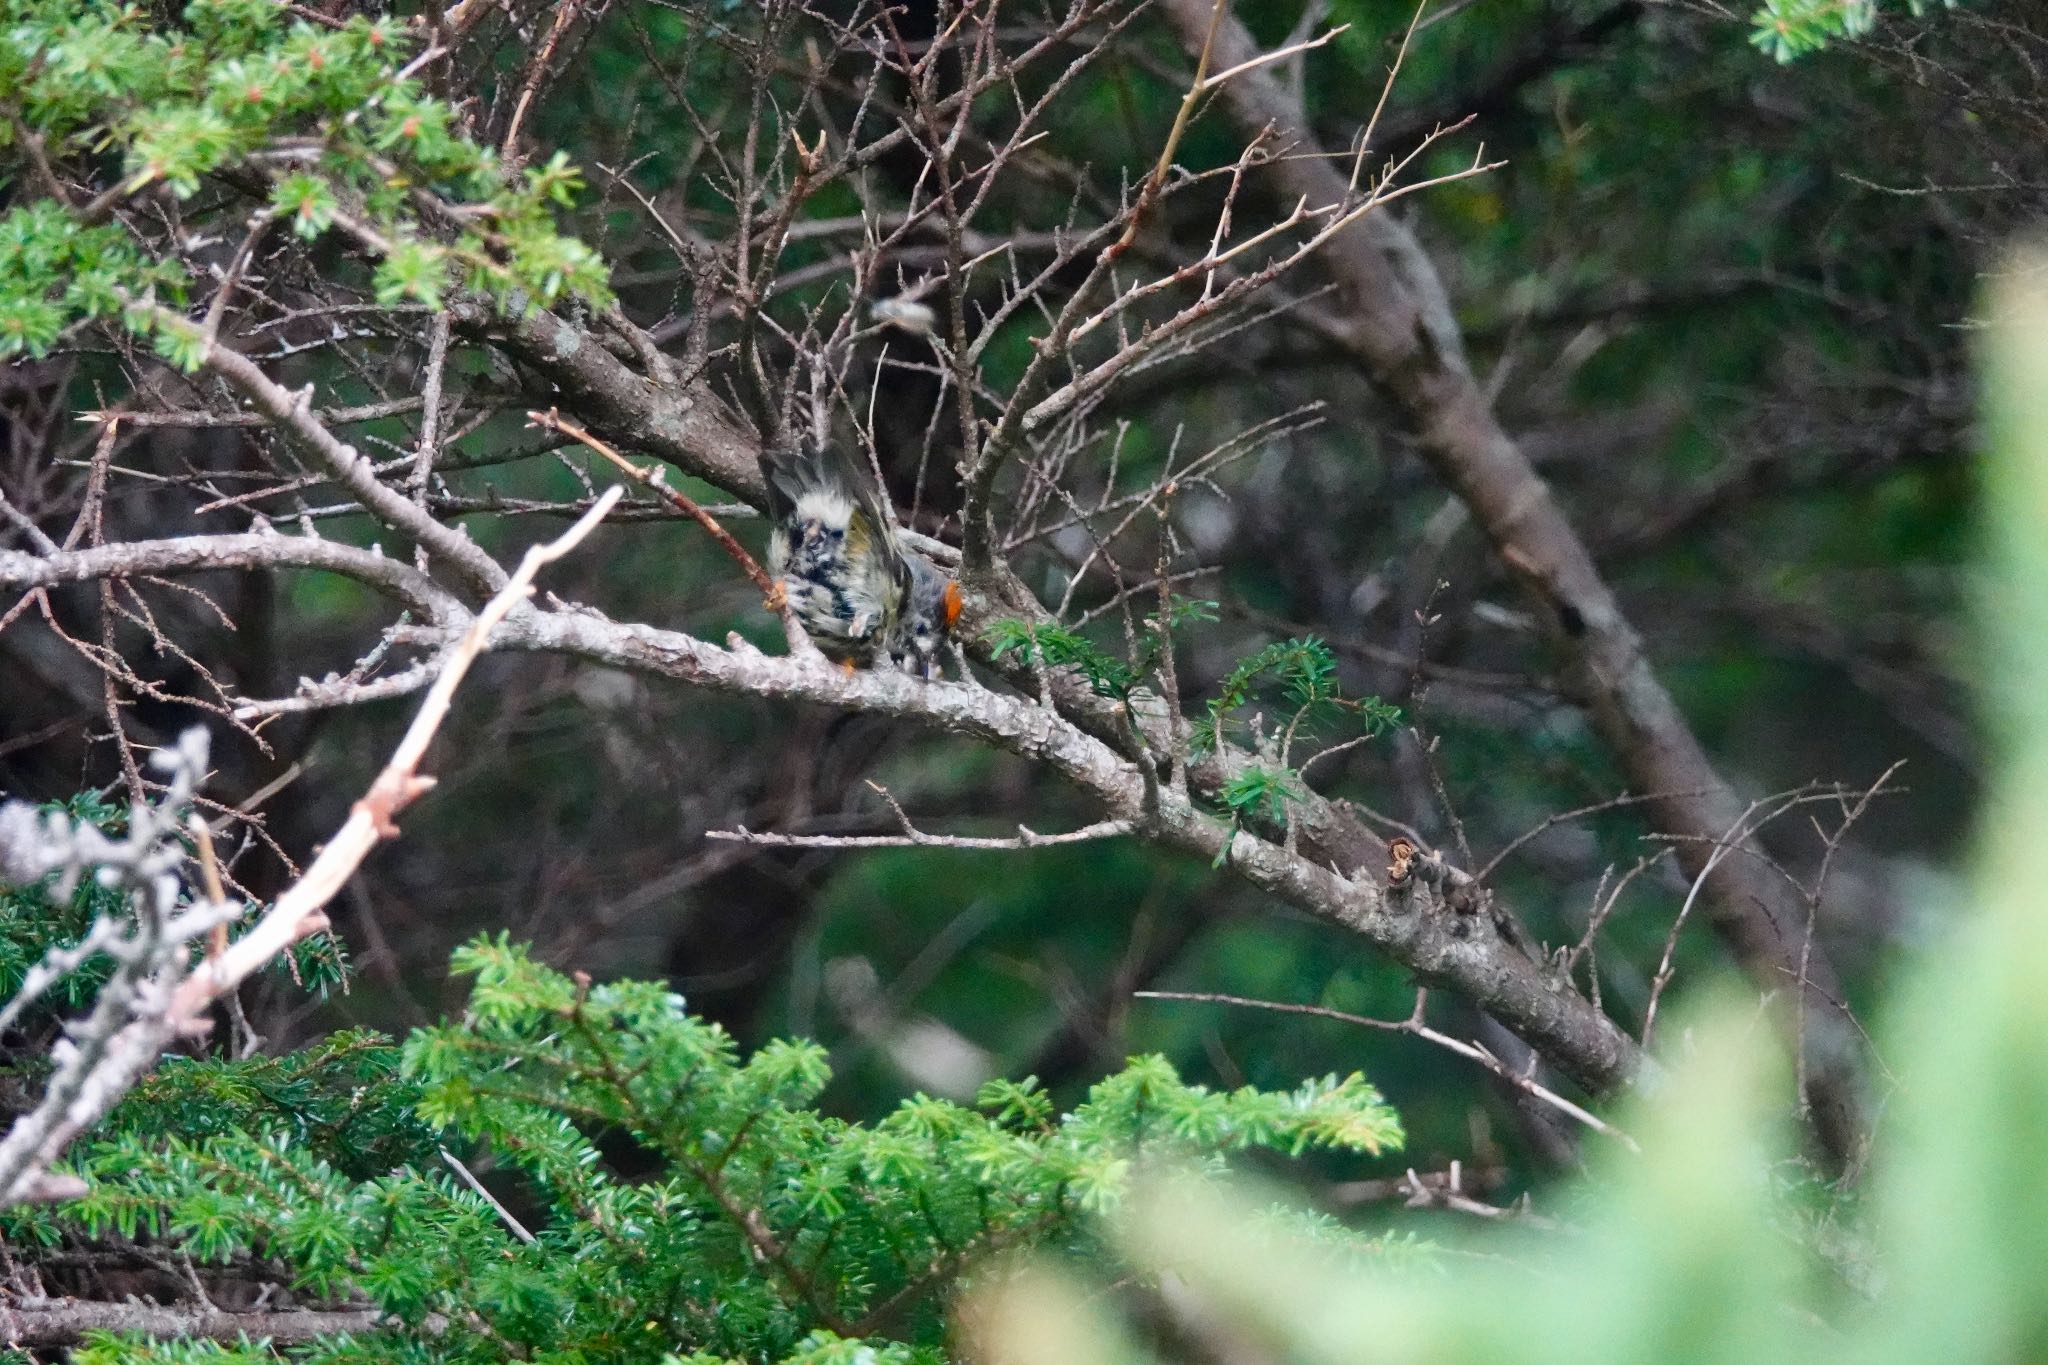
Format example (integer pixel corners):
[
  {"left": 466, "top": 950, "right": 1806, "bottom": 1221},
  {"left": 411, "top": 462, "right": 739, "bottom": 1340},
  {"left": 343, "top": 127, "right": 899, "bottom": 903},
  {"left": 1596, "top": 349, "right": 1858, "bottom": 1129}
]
[{"left": 762, "top": 450, "right": 961, "bottom": 679}]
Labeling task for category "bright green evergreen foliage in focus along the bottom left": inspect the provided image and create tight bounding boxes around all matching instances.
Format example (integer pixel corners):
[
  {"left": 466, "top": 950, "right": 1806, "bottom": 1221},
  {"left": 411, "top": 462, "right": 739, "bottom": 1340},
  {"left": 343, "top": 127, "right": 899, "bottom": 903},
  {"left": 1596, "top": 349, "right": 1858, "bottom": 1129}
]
[{"left": 0, "top": 939, "right": 1401, "bottom": 1365}]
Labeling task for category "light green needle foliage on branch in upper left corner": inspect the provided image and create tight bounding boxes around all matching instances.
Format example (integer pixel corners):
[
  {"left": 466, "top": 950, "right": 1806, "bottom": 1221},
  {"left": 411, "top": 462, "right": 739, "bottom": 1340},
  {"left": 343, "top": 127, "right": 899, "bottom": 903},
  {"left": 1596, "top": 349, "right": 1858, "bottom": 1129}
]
[{"left": 0, "top": 0, "right": 610, "bottom": 368}]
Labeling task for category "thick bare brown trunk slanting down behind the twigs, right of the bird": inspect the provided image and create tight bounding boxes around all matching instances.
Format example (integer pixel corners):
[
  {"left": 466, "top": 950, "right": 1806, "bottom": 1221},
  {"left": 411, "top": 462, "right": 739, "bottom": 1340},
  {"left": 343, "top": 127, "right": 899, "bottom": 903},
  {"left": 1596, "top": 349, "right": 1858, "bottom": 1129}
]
[{"left": 1161, "top": 0, "right": 1866, "bottom": 1166}]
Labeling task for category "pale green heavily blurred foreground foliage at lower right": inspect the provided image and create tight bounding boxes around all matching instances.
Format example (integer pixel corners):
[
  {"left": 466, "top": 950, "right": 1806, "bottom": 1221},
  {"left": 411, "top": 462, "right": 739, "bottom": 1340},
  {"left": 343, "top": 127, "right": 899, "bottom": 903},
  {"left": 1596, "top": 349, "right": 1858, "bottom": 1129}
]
[{"left": 969, "top": 254, "right": 2048, "bottom": 1365}]
